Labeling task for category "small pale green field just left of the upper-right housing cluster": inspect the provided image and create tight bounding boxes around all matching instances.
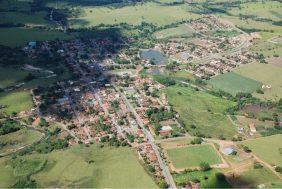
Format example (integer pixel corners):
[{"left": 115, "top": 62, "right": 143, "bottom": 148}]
[{"left": 154, "top": 24, "right": 195, "bottom": 39}]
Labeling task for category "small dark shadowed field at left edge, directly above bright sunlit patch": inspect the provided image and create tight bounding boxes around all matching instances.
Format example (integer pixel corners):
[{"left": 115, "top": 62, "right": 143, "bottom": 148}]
[{"left": 0, "top": 67, "right": 28, "bottom": 88}]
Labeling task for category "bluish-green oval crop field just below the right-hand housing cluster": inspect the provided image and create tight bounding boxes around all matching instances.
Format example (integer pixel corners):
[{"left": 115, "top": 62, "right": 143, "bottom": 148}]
[{"left": 208, "top": 72, "right": 262, "bottom": 95}]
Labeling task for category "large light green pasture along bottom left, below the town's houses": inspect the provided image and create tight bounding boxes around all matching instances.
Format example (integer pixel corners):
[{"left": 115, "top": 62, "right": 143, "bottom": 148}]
[{"left": 0, "top": 145, "right": 157, "bottom": 188}]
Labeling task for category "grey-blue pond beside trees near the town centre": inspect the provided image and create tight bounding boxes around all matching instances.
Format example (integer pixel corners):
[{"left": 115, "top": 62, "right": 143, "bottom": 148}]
[{"left": 140, "top": 49, "right": 167, "bottom": 65}]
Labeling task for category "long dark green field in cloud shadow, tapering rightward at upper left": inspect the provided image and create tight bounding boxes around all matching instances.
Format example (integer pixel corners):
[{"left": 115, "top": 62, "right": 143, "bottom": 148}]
[{"left": 0, "top": 28, "right": 73, "bottom": 47}]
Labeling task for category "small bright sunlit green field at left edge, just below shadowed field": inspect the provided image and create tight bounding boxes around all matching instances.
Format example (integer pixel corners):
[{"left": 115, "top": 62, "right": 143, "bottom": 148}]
[{"left": 0, "top": 91, "right": 33, "bottom": 114}]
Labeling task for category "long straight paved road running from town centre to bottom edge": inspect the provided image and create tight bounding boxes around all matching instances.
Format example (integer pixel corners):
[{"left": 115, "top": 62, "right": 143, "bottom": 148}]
[{"left": 114, "top": 86, "right": 177, "bottom": 188}]
